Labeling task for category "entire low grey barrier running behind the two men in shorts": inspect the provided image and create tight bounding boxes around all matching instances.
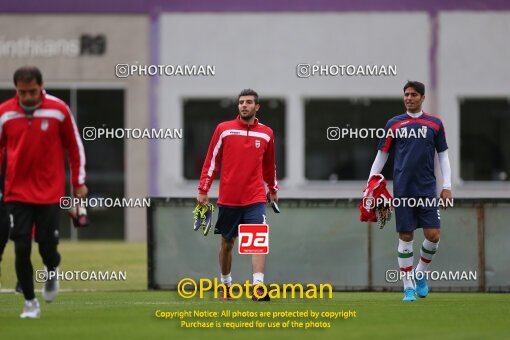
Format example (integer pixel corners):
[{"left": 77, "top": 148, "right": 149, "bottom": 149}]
[{"left": 149, "top": 199, "right": 510, "bottom": 291}]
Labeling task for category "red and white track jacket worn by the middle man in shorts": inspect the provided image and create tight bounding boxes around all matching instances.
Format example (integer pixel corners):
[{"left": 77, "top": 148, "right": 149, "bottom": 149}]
[{"left": 198, "top": 116, "right": 278, "bottom": 206}]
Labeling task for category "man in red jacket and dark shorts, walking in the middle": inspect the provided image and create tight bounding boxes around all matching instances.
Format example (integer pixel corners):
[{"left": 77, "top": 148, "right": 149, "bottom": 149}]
[{"left": 197, "top": 89, "right": 278, "bottom": 301}]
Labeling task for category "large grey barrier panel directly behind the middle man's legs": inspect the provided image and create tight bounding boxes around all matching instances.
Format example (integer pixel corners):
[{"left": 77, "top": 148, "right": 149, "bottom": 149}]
[{"left": 149, "top": 200, "right": 368, "bottom": 289}]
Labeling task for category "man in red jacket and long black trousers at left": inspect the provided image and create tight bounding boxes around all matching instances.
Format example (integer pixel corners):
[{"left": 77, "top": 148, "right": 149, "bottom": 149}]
[{"left": 0, "top": 66, "right": 88, "bottom": 318}]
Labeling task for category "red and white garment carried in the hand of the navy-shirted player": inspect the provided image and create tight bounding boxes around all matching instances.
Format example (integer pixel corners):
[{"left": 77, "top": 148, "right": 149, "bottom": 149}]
[{"left": 359, "top": 174, "right": 393, "bottom": 222}]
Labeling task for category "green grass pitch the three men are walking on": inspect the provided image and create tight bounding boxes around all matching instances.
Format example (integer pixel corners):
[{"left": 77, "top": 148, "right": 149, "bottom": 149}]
[{"left": 0, "top": 242, "right": 510, "bottom": 340}]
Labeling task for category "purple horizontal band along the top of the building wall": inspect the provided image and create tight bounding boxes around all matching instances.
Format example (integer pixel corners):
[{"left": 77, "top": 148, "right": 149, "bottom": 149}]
[{"left": 0, "top": 0, "right": 510, "bottom": 13}]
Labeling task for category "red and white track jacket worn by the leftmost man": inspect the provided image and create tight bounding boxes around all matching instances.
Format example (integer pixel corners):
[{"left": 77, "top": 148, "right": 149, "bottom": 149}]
[{"left": 0, "top": 92, "right": 85, "bottom": 204}]
